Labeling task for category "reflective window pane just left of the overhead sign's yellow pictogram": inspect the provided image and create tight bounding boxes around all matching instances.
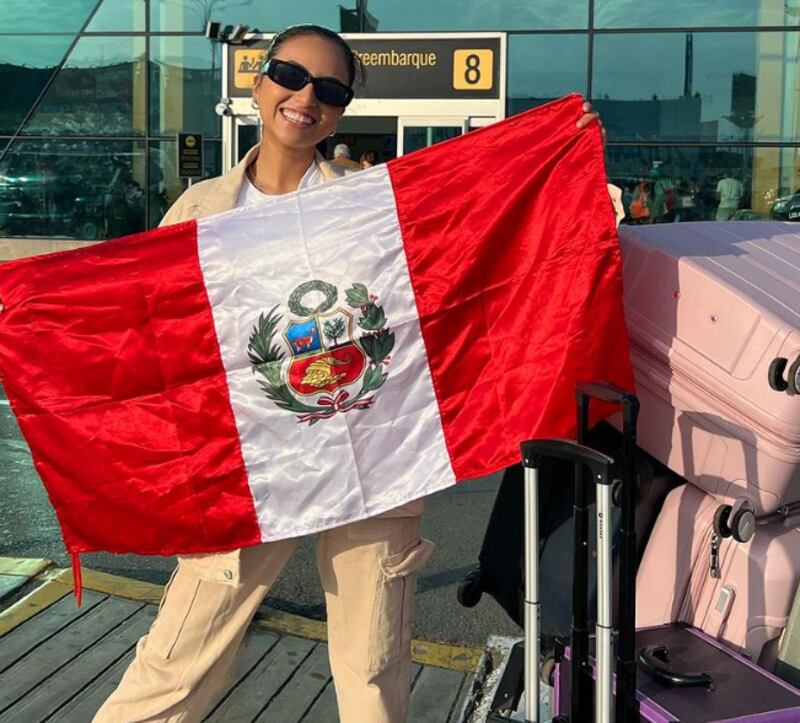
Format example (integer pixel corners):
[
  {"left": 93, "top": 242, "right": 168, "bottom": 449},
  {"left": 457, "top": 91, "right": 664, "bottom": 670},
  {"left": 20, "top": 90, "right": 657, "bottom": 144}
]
[{"left": 150, "top": 37, "right": 222, "bottom": 136}]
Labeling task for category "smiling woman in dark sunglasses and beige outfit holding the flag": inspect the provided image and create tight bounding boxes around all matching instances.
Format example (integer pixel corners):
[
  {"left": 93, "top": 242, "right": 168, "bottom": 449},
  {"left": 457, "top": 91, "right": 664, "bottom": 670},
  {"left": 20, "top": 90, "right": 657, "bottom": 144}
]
[{"left": 94, "top": 25, "right": 608, "bottom": 723}]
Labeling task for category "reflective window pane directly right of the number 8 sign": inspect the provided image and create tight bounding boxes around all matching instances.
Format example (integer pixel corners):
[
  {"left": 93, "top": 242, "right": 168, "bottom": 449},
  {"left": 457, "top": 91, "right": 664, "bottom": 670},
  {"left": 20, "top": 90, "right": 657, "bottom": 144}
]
[{"left": 506, "top": 35, "right": 589, "bottom": 115}]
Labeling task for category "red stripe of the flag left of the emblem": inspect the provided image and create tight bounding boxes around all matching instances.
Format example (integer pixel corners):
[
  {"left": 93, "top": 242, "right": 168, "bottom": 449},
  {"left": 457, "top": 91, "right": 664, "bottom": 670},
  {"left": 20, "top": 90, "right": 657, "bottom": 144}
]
[{"left": 0, "top": 222, "right": 260, "bottom": 554}]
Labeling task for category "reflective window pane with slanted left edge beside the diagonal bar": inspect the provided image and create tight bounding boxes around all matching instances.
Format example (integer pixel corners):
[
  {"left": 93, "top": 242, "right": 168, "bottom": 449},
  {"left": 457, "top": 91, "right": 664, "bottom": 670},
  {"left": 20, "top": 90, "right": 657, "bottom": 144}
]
[{"left": 23, "top": 36, "right": 145, "bottom": 136}]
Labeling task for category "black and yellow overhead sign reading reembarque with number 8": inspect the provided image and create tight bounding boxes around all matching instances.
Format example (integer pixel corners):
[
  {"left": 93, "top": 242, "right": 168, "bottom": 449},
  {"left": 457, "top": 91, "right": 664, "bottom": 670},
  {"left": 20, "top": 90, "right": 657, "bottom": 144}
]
[{"left": 228, "top": 36, "right": 501, "bottom": 100}]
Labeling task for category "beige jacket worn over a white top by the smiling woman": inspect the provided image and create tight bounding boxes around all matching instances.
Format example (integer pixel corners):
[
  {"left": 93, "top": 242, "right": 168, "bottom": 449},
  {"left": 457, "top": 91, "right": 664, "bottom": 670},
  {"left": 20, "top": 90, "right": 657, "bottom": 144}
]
[{"left": 159, "top": 146, "right": 425, "bottom": 585}]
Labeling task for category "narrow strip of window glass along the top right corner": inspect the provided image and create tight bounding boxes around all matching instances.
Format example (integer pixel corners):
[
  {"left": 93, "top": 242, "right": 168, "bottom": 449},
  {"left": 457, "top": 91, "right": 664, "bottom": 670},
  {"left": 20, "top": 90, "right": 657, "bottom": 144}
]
[{"left": 594, "top": 0, "right": 800, "bottom": 28}]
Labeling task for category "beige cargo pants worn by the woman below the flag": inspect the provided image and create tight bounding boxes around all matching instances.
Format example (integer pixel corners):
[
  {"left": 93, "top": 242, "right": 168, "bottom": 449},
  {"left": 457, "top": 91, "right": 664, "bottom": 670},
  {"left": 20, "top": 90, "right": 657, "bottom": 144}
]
[{"left": 94, "top": 516, "right": 433, "bottom": 723}]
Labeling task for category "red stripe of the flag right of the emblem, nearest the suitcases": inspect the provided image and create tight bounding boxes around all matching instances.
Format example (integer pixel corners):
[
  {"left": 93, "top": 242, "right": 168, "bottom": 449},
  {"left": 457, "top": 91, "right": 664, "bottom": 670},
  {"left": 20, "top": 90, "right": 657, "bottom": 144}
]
[{"left": 389, "top": 96, "right": 633, "bottom": 479}]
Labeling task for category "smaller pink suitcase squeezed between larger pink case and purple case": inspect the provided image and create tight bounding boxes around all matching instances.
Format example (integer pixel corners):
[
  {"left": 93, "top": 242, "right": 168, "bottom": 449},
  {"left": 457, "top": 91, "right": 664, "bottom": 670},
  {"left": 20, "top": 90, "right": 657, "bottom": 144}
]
[{"left": 636, "top": 484, "right": 800, "bottom": 670}]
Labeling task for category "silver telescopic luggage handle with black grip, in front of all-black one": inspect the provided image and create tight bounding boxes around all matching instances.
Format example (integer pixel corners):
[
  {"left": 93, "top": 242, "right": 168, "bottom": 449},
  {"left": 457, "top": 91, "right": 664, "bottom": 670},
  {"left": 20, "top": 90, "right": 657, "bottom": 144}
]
[{"left": 520, "top": 439, "right": 614, "bottom": 723}]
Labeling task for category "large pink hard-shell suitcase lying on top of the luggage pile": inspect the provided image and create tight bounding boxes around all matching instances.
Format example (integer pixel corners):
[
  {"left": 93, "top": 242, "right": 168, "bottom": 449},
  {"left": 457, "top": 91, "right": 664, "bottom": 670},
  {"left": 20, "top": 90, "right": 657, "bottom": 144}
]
[{"left": 619, "top": 221, "right": 800, "bottom": 515}]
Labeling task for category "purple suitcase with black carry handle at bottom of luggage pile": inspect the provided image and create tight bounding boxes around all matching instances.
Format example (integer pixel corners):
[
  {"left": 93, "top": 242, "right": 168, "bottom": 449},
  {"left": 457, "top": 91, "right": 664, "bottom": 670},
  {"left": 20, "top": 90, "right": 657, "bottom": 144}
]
[{"left": 553, "top": 624, "right": 800, "bottom": 723}]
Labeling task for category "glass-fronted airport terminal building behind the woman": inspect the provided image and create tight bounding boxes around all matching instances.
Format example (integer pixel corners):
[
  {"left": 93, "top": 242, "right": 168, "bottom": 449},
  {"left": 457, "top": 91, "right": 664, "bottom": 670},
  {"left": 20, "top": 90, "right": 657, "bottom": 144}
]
[{"left": 0, "top": 0, "right": 800, "bottom": 252}]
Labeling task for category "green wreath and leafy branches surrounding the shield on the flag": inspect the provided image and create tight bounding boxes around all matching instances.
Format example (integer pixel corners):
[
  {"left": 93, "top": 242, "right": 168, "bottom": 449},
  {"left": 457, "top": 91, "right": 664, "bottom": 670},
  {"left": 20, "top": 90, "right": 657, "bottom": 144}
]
[{"left": 247, "top": 280, "right": 394, "bottom": 426}]
